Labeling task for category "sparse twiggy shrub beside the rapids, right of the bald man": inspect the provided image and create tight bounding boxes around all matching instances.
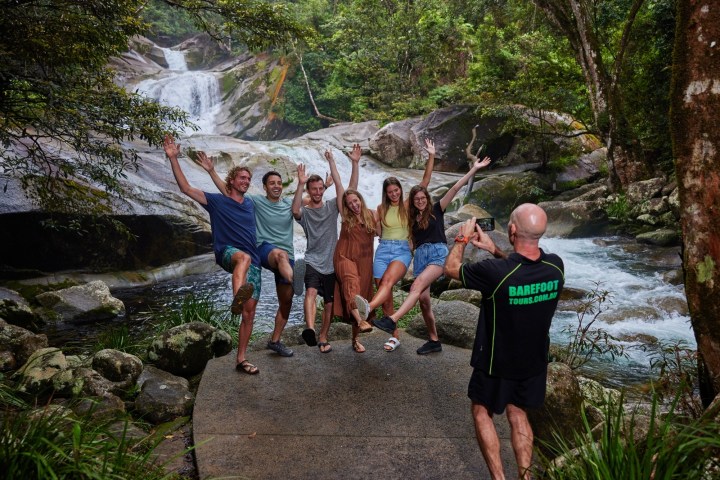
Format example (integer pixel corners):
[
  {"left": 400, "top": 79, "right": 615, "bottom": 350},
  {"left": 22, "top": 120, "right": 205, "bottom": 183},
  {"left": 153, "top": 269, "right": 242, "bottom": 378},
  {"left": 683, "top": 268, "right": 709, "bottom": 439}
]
[{"left": 556, "top": 283, "right": 627, "bottom": 370}]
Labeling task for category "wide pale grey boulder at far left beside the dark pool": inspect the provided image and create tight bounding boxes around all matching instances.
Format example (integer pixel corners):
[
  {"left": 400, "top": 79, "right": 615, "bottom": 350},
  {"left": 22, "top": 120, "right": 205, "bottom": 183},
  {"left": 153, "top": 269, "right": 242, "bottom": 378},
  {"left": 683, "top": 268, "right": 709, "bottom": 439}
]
[{"left": 35, "top": 280, "right": 125, "bottom": 322}]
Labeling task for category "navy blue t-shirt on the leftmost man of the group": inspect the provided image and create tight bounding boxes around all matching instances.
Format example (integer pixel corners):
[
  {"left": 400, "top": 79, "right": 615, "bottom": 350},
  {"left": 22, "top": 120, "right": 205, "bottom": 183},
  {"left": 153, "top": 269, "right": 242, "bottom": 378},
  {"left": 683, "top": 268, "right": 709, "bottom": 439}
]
[{"left": 203, "top": 192, "right": 260, "bottom": 266}]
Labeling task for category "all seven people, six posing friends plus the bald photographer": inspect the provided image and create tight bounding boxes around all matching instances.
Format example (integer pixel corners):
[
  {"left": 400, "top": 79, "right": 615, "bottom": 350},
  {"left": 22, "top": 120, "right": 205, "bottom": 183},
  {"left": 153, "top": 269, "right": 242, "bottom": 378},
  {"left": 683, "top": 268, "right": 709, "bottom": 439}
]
[{"left": 164, "top": 136, "right": 564, "bottom": 479}]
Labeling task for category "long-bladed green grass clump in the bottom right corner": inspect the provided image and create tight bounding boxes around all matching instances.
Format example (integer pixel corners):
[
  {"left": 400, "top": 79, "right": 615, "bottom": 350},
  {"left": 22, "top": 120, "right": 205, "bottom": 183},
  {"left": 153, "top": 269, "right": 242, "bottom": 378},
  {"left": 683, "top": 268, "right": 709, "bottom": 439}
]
[{"left": 541, "top": 401, "right": 720, "bottom": 480}]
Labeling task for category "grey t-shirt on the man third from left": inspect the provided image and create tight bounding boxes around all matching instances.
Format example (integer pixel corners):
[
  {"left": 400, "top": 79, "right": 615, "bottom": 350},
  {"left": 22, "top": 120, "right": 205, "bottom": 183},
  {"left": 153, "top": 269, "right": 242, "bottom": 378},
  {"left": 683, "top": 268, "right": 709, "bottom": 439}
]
[{"left": 297, "top": 198, "right": 340, "bottom": 275}]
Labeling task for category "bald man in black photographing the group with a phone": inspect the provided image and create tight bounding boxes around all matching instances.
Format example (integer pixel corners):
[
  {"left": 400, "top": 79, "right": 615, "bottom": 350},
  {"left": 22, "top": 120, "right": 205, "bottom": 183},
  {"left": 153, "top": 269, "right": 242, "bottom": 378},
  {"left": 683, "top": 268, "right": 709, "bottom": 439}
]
[{"left": 445, "top": 203, "right": 565, "bottom": 479}]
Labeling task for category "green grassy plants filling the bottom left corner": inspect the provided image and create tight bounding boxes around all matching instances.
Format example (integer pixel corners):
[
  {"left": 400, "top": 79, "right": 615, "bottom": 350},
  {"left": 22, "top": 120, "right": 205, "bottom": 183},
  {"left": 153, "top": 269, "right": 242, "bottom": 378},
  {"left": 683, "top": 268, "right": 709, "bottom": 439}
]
[{"left": 0, "top": 407, "right": 168, "bottom": 480}]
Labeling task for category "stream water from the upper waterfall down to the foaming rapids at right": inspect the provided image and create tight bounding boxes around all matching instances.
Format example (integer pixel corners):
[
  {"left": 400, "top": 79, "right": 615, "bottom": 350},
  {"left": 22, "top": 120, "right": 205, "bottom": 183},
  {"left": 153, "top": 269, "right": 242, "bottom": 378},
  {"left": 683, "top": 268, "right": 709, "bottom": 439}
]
[{"left": 116, "top": 49, "right": 695, "bottom": 384}]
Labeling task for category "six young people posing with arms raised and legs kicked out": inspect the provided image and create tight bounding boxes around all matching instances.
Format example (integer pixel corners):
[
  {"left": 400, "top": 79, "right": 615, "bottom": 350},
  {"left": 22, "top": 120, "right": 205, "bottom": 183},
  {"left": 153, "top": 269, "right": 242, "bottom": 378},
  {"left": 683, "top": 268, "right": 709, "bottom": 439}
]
[{"left": 164, "top": 136, "right": 490, "bottom": 374}]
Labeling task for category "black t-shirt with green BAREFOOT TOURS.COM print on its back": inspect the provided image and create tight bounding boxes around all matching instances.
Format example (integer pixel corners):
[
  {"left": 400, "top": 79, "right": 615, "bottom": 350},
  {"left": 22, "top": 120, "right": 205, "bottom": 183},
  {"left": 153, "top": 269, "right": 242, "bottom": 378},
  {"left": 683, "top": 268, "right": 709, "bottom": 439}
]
[{"left": 460, "top": 250, "right": 565, "bottom": 380}]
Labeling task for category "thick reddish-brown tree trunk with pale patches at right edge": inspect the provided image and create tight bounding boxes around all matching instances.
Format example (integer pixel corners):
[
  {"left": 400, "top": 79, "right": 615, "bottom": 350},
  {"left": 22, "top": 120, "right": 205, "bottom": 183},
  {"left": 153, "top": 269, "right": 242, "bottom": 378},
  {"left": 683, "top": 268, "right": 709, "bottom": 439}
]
[{"left": 671, "top": 0, "right": 720, "bottom": 406}]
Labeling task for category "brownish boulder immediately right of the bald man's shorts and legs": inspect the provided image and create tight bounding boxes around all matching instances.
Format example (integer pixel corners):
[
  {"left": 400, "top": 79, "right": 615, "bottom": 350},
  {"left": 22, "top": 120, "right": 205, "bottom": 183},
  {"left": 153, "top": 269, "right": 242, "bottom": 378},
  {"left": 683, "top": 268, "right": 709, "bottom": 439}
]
[{"left": 528, "top": 362, "right": 584, "bottom": 449}]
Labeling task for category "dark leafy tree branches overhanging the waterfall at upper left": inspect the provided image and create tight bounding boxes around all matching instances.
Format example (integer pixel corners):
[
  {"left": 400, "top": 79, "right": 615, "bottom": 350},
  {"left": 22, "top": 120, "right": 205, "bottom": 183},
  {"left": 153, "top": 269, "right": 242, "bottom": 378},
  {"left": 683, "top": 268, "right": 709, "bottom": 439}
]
[{"left": 0, "top": 0, "right": 305, "bottom": 213}]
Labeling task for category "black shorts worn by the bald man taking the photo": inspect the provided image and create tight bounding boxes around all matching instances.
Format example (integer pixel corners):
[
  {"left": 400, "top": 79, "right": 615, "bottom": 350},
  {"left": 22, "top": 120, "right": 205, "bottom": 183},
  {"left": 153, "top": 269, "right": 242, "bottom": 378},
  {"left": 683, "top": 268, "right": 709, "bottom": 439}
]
[{"left": 468, "top": 367, "right": 547, "bottom": 415}]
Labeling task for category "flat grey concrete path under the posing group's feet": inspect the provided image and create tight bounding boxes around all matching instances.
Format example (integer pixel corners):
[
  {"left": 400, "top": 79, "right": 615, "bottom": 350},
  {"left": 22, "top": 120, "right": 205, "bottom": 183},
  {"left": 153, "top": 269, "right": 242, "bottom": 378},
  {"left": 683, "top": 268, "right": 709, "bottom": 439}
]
[{"left": 193, "top": 329, "right": 516, "bottom": 480}]
